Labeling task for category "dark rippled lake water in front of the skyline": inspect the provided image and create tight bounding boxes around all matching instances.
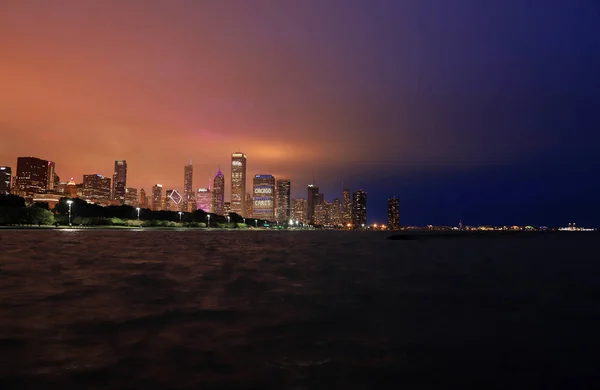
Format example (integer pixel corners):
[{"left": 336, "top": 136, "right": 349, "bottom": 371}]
[{"left": 0, "top": 230, "right": 600, "bottom": 389}]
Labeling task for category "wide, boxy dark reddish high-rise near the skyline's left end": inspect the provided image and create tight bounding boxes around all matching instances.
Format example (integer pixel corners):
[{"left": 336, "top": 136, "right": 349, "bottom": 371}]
[{"left": 15, "top": 157, "right": 52, "bottom": 202}]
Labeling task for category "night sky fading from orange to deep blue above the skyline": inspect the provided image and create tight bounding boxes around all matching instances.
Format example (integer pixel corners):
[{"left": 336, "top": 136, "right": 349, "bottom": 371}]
[{"left": 0, "top": 0, "right": 600, "bottom": 227}]
